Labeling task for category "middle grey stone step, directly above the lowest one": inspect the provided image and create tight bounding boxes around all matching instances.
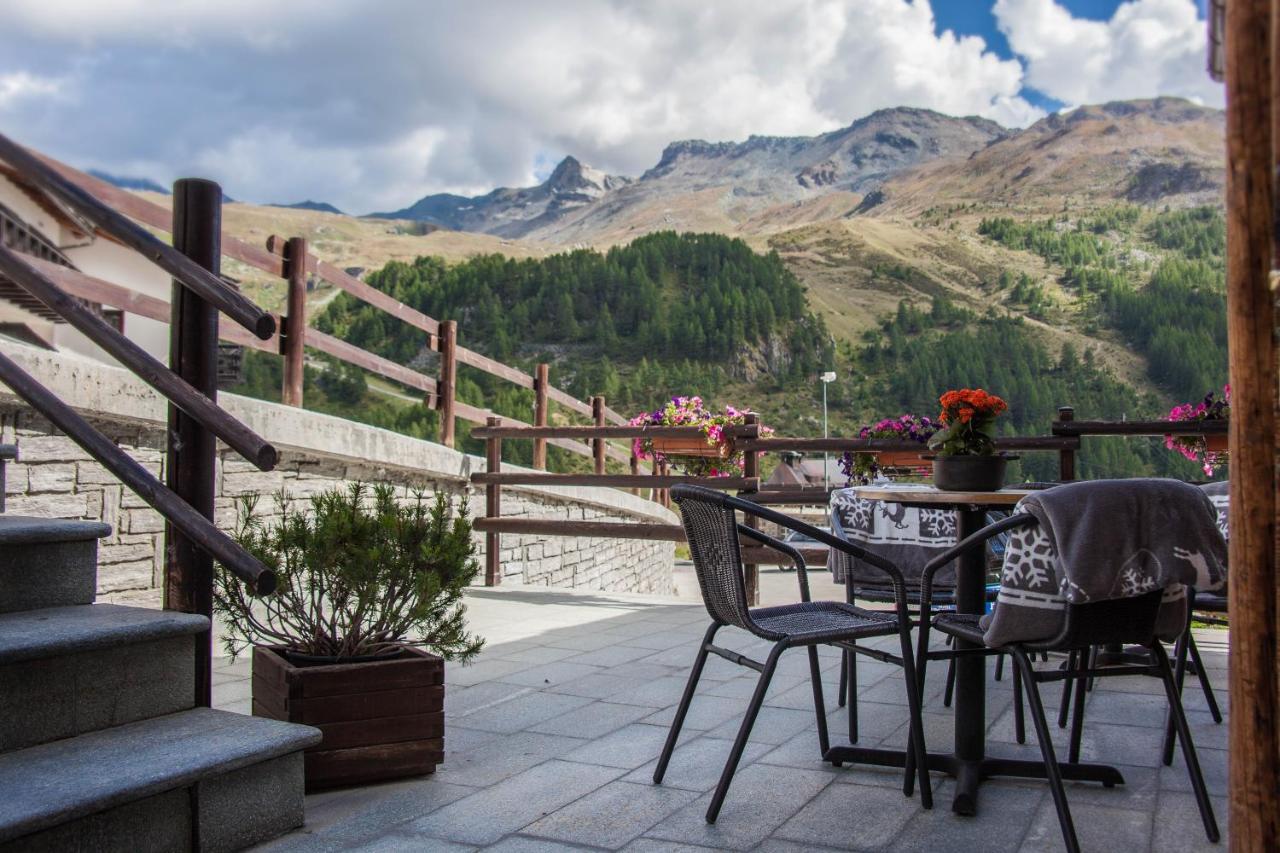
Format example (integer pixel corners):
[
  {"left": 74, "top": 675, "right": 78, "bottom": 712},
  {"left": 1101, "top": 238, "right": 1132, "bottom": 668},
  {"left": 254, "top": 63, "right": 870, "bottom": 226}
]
[{"left": 0, "top": 605, "right": 209, "bottom": 753}]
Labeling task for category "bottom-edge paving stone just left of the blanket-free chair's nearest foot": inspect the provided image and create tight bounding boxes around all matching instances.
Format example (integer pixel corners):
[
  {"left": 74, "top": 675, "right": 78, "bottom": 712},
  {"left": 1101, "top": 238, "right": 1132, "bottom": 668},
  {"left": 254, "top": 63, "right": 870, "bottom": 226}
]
[{"left": 522, "top": 781, "right": 696, "bottom": 848}]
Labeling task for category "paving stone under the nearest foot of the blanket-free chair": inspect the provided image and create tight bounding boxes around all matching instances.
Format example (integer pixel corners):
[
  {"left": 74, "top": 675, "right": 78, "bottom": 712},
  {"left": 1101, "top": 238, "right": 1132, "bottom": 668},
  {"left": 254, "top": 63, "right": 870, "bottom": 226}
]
[{"left": 646, "top": 765, "right": 831, "bottom": 850}]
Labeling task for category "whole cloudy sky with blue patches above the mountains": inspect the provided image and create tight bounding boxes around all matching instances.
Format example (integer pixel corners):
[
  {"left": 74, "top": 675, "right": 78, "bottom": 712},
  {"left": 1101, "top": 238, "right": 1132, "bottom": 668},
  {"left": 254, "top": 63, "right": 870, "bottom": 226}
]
[{"left": 0, "top": 0, "right": 1224, "bottom": 213}]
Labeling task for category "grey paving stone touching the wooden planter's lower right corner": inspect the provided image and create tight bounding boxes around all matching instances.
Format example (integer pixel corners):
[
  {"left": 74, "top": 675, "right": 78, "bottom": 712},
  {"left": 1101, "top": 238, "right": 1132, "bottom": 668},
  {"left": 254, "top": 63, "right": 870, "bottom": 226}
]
[{"left": 435, "top": 721, "right": 586, "bottom": 788}]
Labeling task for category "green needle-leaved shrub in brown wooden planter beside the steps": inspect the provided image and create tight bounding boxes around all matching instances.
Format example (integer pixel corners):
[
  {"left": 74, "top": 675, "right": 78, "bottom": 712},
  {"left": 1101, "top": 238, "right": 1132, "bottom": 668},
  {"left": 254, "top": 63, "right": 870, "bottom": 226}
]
[{"left": 214, "top": 483, "right": 484, "bottom": 790}]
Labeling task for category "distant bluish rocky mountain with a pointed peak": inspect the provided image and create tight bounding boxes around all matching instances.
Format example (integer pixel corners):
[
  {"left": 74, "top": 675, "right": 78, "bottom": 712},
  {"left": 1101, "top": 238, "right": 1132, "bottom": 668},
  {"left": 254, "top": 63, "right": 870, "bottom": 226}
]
[{"left": 369, "top": 156, "right": 631, "bottom": 237}]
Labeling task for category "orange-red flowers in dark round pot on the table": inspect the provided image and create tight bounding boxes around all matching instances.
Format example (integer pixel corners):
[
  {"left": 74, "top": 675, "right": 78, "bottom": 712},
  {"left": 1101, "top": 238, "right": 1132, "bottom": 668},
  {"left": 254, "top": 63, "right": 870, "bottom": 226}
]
[{"left": 929, "top": 388, "right": 1009, "bottom": 492}]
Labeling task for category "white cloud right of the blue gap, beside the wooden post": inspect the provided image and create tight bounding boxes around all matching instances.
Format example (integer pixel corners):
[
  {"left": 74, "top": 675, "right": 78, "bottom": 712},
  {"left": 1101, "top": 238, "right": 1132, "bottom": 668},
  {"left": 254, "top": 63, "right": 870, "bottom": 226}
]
[{"left": 993, "top": 0, "right": 1224, "bottom": 106}]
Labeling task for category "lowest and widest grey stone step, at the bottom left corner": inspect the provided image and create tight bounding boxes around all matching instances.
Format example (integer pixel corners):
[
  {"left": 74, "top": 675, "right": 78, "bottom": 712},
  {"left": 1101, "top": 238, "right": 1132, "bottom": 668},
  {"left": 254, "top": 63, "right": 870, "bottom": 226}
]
[{"left": 0, "top": 708, "right": 320, "bottom": 853}]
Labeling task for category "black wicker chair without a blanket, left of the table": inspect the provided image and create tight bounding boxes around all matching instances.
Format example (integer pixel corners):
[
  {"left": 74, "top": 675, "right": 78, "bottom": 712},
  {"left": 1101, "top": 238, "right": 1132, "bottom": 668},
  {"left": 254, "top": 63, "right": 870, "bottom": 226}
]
[{"left": 653, "top": 485, "right": 933, "bottom": 824}]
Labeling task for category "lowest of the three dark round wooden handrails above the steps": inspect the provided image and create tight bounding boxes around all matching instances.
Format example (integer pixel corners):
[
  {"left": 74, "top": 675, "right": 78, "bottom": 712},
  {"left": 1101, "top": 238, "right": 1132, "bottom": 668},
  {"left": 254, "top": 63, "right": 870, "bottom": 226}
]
[{"left": 0, "top": 353, "right": 275, "bottom": 596}]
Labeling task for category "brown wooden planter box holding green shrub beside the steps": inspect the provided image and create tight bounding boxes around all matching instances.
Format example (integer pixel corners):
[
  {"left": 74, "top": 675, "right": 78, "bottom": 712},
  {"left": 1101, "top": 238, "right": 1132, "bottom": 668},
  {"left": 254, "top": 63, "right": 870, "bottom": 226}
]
[{"left": 253, "top": 646, "right": 444, "bottom": 792}]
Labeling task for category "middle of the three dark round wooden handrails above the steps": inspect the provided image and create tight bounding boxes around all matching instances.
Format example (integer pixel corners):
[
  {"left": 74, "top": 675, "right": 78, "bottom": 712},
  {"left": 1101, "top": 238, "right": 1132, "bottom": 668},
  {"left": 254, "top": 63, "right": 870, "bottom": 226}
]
[{"left": 0, "top": 246, "right": 279, "bottom": 471}]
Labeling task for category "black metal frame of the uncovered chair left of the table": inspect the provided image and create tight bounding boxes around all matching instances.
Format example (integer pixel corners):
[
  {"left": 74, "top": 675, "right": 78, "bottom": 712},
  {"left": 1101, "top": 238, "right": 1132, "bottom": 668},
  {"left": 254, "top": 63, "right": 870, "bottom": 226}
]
[{"left": 653, "top": 484, "right": 933, "bottom": 824}]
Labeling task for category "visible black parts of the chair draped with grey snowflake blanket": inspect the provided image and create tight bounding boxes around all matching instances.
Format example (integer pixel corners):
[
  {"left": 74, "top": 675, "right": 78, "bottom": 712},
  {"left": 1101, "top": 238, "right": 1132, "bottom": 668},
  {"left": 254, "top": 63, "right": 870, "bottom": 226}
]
[{"left": 906, "top": 514, "right": 1220, "bottom": 852}]
